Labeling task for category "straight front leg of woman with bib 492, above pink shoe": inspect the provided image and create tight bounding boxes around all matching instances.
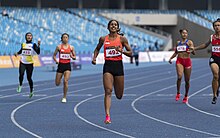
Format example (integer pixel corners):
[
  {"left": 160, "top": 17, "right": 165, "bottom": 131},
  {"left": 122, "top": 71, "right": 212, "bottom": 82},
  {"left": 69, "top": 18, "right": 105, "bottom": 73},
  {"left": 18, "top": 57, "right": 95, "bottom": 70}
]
[{"left": 103, "top": 72, "right": 114, "bottom": 116}]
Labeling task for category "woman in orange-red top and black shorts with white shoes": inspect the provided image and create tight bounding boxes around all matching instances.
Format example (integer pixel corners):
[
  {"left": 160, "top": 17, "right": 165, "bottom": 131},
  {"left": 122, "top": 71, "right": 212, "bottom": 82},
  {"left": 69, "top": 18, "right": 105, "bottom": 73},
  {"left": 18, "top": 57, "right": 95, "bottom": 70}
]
[{"left": 53, "top": 33, "right": 76, "bottom": 103}]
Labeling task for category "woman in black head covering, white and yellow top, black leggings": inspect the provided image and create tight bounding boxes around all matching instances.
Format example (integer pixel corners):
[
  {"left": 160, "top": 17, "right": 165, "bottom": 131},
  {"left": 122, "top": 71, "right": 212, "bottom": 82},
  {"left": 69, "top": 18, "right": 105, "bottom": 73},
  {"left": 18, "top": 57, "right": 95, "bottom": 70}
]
[{"left": 14, "top": 32, "right": 40, "bottom": 98}]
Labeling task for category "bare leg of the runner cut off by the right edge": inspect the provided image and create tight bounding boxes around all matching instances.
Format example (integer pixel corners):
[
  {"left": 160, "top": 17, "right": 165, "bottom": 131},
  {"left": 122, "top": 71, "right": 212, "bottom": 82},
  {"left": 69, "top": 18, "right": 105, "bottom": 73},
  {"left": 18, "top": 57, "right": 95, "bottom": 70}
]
[{"left": 210, "top": 63, "right": 219, "bottom": 97}]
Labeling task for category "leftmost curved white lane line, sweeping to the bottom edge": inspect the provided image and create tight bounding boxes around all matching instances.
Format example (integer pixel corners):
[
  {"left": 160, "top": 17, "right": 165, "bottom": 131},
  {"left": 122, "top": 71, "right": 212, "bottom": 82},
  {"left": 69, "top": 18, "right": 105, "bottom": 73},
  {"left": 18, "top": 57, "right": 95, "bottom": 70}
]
[{"left": 11, "top": 86, "right": 100, "bottom": 138}]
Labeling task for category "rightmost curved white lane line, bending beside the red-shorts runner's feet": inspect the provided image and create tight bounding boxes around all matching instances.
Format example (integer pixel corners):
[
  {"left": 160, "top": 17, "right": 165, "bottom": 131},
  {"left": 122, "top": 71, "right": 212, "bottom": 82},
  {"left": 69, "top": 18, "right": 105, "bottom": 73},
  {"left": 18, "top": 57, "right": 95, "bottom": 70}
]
[{"left": 186, "top": 85, "right": 220, "bottom": 118}]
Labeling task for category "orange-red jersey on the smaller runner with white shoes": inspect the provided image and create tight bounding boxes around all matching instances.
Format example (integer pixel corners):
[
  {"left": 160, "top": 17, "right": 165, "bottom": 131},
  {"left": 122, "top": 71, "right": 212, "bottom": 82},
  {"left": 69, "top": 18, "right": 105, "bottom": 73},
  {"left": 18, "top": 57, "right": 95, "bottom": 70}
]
[{"left": 59, "top": 44, "right": 71, "bottom": 63}]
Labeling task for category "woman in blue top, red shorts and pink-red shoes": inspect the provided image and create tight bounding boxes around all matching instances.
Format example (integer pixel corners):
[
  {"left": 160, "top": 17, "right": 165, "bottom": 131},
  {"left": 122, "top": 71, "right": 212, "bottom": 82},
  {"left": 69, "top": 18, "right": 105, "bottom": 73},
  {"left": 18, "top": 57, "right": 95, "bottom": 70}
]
[{"left": 169, "top": 29, "right": 194, "bottom": 103}]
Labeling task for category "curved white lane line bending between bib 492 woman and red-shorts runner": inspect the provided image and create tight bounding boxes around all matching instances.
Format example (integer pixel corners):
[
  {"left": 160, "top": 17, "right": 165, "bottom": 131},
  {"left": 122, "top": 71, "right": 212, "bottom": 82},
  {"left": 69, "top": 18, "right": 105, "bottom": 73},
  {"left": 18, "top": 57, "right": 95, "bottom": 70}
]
[{"left": 131, "top": 74, "right": 220, "bottom": 136}]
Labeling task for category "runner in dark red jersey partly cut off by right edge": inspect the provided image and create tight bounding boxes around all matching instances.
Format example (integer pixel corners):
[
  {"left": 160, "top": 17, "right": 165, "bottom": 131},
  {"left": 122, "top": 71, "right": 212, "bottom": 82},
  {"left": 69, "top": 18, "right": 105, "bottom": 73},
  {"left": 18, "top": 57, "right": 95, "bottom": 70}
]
[{"left": 195, "top": 18, "right": 220, "bottom": 104}]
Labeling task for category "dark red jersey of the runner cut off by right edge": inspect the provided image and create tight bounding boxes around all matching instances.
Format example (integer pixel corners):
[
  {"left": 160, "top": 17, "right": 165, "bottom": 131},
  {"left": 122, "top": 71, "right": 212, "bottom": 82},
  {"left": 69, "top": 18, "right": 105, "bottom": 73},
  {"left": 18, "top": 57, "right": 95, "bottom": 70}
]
[{"left": 211, "top": 34, "right": 220, "bottom": 57}]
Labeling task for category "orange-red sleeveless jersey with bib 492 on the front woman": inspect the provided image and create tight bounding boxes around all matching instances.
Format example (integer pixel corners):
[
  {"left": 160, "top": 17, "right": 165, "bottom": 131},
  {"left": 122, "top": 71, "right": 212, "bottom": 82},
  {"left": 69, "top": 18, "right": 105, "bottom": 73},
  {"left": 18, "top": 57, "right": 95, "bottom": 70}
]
[{"left": 104, "top": 35, "right": 123, "bottom": 61}]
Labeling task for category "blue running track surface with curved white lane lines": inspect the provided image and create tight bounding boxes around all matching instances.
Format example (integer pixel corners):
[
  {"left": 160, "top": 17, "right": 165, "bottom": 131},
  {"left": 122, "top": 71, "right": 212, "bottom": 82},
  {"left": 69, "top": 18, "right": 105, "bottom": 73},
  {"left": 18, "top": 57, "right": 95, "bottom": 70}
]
[{"left": 0, "top": 59, "right": 220, "bottom": 138}]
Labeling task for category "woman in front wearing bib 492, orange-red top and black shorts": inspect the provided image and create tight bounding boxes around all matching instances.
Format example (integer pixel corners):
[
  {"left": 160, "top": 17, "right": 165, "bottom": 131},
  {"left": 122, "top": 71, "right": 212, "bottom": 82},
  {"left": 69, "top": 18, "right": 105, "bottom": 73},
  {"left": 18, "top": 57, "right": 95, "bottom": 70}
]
[{"left": 92, "top": 20, "right": 132, "bottom": 124}]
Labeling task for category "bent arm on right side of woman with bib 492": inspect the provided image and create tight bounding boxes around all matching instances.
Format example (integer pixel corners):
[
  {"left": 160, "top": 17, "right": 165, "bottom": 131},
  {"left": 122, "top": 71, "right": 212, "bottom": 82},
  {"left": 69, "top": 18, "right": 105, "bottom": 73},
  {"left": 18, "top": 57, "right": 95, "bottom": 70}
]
[{"left": 119, "top": 36, "right": 132, "bottom": 57}]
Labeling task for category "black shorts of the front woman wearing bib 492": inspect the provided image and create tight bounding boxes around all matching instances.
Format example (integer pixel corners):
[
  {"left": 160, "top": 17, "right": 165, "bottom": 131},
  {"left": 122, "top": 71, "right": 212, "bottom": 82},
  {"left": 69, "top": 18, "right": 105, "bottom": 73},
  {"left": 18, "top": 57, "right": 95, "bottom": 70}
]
[{"left": 103, "top": 60, "right": 124, "bottom": 76}]
